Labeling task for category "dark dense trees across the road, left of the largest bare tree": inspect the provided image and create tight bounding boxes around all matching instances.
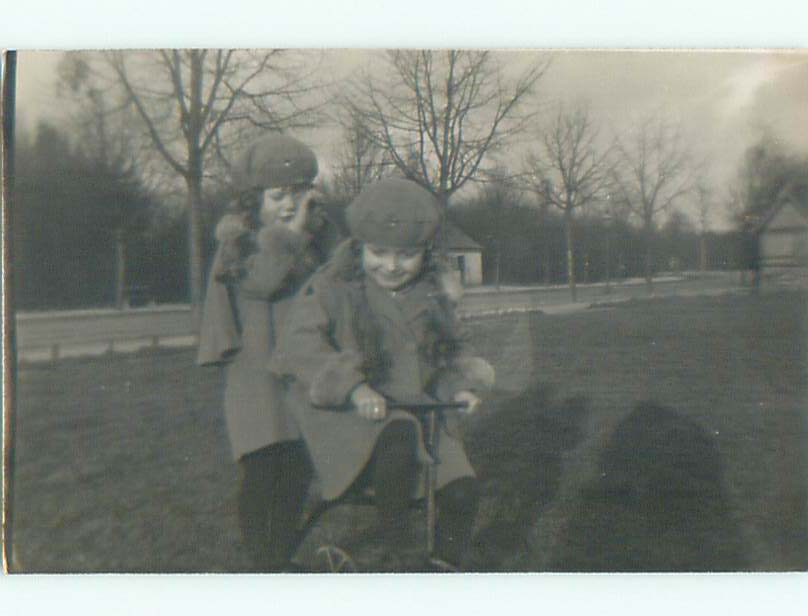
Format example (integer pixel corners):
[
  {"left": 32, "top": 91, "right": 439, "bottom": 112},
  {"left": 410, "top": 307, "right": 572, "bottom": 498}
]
[{"left": 12, "top": 124, "right": 188, "bottom": 310}]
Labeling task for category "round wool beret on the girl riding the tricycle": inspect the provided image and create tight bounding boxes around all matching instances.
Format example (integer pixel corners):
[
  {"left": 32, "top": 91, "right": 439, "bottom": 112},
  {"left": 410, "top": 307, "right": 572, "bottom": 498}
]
[{"left": 347, "top": 178, "right": 440, "bottom": 248}]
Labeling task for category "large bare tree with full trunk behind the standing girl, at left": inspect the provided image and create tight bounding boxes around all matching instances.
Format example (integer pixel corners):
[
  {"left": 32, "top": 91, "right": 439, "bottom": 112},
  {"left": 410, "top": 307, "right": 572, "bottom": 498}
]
[{"left": 64, "top": 49, "right": 322, "bottom": 324}]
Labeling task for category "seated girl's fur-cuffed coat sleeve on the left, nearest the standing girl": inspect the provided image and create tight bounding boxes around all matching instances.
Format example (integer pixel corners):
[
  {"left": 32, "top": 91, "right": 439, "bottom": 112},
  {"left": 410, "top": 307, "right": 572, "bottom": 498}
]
[{"left": 270, "top": 276, "right": 365, "bottom": 406}]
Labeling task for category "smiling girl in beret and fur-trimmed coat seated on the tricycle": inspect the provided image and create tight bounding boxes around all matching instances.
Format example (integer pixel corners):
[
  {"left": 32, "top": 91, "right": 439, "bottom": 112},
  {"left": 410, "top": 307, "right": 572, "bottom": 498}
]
[{"left": 271, "top": 179, "right": 493, "bottom": 564}]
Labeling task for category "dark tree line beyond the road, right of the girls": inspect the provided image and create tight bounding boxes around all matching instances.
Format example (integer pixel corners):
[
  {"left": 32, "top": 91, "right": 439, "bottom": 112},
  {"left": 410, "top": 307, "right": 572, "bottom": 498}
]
[{"left": 449, "top": 183, "right": 742, "bottom": 285}]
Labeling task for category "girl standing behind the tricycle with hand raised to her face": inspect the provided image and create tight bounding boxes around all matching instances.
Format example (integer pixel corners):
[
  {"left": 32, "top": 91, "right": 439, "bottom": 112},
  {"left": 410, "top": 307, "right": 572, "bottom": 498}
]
[{"left": 198, "top": 135, "right": 332, "bottom": 572}]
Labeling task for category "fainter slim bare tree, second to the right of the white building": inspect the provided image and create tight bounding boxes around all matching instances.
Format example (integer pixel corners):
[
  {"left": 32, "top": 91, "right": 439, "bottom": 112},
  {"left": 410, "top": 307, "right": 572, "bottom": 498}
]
[{"left": 612, "top": 117, "right": 691, "bottom": 291}]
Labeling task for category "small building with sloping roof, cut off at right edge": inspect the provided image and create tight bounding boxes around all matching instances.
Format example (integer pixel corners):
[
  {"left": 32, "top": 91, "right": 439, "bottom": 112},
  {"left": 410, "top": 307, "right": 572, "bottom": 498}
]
[{"left": 758, "top": 186, "right": 808, "bottom": 273}]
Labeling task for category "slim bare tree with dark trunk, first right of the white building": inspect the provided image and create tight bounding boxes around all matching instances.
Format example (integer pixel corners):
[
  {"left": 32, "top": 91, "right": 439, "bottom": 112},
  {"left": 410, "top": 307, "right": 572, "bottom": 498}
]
[{"left": 524, "top": 106, "right": 611, "bottom": 301}]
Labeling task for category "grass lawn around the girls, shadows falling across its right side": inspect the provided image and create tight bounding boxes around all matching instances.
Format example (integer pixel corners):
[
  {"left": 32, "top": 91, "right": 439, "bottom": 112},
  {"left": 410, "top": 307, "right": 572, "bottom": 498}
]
[{"left": 7, "top": 292, "right": 808, "bottom": 572}]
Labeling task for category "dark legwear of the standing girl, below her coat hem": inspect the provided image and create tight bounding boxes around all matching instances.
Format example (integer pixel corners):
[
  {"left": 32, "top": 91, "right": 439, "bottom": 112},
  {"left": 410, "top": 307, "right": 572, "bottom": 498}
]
[{"left": 238, "top": 441, "right": 312, "bottom": 572}]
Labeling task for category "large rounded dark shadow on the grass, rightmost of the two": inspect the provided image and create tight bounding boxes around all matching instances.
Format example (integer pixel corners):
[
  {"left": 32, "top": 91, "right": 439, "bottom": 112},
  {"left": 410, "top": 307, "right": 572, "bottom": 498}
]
[{"left": 550, "top": 402, "right": 748, "bottom": 572}]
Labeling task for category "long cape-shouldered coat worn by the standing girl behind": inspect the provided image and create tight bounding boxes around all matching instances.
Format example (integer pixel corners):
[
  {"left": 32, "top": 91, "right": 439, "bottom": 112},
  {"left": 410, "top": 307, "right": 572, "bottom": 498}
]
[{"left": 197, "top": 227, "right": 319, "bottom": 459}]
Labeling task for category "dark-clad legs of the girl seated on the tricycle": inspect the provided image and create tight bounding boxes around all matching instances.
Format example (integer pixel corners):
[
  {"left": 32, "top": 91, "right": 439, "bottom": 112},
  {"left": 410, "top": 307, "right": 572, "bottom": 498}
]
[{"left": 360, "top": 421, "right": 479, "bottom": 564}]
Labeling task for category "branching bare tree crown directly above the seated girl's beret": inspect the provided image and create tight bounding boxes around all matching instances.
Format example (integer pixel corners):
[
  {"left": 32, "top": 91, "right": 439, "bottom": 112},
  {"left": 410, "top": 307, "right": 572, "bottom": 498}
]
[{"left": 349, "top": 50, "right": 549, "bottom": 231}]
